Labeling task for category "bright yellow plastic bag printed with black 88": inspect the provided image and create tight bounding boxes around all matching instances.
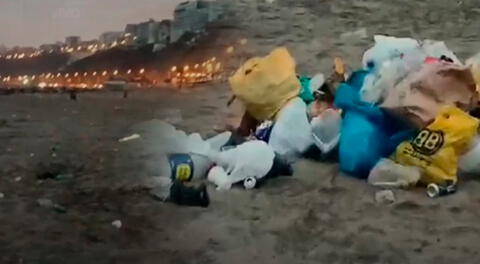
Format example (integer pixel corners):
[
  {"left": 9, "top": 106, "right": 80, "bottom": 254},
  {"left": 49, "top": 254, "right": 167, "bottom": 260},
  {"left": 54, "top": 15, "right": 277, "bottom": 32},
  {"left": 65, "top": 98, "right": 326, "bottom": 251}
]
[{"left": 393, "top": 106, "right": 478, "bottom": 184}]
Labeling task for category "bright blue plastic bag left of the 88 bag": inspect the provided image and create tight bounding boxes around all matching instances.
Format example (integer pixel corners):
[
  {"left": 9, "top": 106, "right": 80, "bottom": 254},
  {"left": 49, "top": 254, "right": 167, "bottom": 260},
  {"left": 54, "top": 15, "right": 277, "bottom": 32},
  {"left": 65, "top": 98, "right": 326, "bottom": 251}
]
[{"left": 335, "top": 70, "right": 415, "bottom": 178}]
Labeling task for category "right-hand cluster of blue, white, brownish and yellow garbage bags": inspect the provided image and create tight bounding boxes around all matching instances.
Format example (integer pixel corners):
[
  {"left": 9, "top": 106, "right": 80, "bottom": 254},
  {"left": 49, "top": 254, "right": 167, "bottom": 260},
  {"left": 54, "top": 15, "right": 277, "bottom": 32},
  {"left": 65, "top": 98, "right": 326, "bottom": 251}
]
[{"left": 335, "top": 36, "right": 480, "bottom": 197}]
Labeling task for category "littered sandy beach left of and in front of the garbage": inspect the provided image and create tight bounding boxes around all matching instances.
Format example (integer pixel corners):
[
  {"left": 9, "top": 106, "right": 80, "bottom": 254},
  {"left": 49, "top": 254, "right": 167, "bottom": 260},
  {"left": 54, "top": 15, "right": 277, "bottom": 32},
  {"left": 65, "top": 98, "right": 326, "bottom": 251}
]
[{"left": 0, "top": 84, "right": 480, "bottom": 263}]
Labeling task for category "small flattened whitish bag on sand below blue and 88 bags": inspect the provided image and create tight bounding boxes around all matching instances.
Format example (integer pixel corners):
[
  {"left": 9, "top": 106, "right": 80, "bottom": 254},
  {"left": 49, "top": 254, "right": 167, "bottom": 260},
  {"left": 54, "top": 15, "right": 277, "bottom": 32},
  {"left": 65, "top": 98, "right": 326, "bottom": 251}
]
[{"left": 368, "top": 159, "right": 422, "bottom": 188}]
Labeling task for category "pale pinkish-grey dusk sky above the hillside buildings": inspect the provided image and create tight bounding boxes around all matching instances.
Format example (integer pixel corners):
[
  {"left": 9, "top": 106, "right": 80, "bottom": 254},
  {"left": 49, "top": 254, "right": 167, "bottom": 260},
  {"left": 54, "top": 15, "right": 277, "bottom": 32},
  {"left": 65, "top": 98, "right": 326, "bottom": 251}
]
[{"left": 0, "top": 0, "right": 185, "bottom": 47}]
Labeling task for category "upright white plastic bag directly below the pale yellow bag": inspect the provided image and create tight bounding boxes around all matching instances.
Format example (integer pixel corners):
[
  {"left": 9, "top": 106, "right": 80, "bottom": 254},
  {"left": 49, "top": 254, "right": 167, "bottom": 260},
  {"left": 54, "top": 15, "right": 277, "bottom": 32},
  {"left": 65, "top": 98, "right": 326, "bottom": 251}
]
[{"left": 268, "top": 97, "right": 314, "bottom": 159}]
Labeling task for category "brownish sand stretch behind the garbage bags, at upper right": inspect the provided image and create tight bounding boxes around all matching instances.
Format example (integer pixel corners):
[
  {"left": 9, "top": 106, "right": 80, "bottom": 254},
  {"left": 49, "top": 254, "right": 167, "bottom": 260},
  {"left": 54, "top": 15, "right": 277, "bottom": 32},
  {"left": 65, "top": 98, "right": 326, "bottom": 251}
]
[{"left": 225, "top": 0, "right": 480, "bottom": 73}]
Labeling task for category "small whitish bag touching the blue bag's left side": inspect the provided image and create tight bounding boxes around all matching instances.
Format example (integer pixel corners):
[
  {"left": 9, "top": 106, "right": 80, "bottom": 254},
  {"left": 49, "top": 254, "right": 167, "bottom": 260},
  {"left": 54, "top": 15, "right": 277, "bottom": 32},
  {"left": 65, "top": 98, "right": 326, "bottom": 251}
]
[{"left": 311, "top": 109, "right": 342, "bottom": 154}]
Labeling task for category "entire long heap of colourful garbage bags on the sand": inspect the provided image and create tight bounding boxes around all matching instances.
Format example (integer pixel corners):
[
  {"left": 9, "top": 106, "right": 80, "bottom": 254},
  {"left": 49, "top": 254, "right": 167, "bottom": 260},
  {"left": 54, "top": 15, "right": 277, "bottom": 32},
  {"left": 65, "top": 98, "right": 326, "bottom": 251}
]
[{"left": 121, "top": 35, "right": 480, "bottom": 207}]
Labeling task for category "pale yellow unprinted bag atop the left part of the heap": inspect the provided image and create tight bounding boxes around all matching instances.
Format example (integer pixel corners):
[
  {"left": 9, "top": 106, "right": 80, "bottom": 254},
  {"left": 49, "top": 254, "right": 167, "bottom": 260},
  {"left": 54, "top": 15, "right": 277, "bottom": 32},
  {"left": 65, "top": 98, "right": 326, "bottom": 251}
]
[{"left": 229, "top": 48, "right": 300, "bottom": 121}]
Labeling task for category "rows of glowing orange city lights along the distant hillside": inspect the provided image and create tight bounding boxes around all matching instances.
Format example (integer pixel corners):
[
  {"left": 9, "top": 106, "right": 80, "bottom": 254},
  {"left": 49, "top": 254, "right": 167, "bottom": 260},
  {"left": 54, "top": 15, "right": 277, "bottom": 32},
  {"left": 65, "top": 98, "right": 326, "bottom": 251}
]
[{"left": 0, "top": 37, "right": 246, "bottom": 89}]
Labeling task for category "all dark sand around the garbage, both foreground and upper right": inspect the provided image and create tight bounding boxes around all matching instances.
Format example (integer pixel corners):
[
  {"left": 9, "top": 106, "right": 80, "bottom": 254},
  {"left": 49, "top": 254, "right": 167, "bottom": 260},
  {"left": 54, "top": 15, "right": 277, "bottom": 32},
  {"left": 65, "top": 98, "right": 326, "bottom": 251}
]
[{"left": 0, "top": 0, "right": 480, "bottom": 264}]
